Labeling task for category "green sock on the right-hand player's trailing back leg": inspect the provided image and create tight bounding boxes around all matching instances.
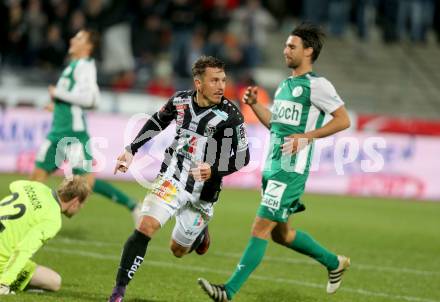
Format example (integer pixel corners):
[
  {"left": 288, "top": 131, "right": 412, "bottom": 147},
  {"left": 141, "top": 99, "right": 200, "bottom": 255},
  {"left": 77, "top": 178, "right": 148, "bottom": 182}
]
[{"left": 289, "top": 230, "right": 339, "bottom": 270}]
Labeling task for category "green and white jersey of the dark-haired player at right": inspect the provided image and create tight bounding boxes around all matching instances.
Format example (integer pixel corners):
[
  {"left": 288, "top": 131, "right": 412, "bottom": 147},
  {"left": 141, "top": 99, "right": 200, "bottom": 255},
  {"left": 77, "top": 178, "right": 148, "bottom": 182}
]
[{"left": 264, "top": 72, "right": 344, "bottom": 176}]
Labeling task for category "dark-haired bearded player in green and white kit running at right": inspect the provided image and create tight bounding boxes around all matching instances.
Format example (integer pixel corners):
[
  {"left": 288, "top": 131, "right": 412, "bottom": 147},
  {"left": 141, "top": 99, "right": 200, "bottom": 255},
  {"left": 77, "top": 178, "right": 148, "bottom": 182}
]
[{"left": 199, "top": 24, "right": 350, "bottom": 301}]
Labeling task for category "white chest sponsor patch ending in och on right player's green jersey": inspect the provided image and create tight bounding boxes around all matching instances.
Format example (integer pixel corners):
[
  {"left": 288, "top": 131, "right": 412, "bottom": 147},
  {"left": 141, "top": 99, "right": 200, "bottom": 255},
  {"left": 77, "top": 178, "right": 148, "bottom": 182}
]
[{"left": 271, "top": 100, "right": 303, "bottom": 126}]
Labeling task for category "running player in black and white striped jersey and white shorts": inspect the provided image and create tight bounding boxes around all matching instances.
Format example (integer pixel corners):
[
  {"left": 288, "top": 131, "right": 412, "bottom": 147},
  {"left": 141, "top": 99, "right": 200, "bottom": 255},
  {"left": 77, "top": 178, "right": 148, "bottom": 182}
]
[{"left": 109, "top": 56, "right": 249, "bottom": 302}]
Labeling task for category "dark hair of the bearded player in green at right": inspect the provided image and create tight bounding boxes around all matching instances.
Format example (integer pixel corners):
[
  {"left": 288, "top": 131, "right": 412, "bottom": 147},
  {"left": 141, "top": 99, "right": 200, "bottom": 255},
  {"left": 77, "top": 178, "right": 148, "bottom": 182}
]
[{"left": 290, "top": 22, "right": 325, "bottom": 63}]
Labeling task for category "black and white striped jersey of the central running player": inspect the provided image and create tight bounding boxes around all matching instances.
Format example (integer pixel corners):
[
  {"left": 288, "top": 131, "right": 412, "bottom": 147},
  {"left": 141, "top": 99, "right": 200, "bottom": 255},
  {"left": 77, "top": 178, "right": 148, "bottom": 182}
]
[{"left": 127, "top": 90, "right": 250, "bottom": 202}]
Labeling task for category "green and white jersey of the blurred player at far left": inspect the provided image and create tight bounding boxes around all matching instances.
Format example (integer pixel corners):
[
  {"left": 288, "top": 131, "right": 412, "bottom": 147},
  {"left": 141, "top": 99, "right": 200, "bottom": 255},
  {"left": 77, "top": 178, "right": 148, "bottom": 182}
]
[{"left": 51, "top": 58, "right": 99, "bottom": 134}]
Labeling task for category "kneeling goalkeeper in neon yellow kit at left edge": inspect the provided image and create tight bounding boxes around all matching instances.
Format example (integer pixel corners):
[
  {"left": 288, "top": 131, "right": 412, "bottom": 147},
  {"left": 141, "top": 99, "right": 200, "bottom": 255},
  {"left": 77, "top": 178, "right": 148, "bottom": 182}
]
[{"left": 0, "top": 176, "right": 90, "bottom": 295}]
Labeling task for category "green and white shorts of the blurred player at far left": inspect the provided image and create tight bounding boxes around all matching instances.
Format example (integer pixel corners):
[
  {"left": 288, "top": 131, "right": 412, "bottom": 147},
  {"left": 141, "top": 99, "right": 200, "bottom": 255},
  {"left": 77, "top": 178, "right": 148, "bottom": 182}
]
[{"left": 35, "top": 132, "right": 93, "bottom": 174}]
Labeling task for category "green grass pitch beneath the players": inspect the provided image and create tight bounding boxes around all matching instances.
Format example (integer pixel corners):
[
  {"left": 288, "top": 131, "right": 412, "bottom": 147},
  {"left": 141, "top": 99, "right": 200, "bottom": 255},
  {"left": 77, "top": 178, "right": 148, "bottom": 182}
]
[{"left": 0, "top": 175, "right": 440, "bottom": 302}]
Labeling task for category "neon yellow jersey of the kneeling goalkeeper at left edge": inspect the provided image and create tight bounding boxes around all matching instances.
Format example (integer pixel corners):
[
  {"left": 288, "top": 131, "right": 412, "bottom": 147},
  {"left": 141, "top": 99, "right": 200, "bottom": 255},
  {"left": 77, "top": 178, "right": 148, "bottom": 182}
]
[{"left": 0, "top": 180, "right": 61, "bottom": 285}]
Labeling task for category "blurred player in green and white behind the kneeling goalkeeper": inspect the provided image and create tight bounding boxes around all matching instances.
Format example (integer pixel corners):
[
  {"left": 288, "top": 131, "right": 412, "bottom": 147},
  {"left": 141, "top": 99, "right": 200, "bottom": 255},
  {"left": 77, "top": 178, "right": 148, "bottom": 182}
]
[{"left": 31, "top": 29, "right": 140, "bottom": 220}]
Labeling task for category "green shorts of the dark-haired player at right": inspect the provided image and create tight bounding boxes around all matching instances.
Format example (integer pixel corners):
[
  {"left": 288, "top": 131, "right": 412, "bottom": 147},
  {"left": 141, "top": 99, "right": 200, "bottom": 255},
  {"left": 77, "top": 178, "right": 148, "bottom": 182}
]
[{"left": 257, "top": 171, "right": 308, "bottom": 222}]
